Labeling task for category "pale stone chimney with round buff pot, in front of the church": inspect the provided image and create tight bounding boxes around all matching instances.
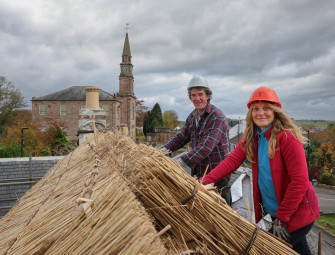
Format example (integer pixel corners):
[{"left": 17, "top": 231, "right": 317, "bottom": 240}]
[{"left": 78, "top": 87, "right": 107, "bottom": 145}]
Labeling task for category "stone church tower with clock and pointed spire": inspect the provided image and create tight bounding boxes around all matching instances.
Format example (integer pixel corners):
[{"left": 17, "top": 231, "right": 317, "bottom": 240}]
[{"left": 117, "top": 33, "right": 136, "bottom": 140}]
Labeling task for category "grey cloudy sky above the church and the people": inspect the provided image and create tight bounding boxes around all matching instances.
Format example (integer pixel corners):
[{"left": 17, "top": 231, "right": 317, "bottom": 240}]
[{"left": 0, "top": 0, "right": 335, "bottom": 120}]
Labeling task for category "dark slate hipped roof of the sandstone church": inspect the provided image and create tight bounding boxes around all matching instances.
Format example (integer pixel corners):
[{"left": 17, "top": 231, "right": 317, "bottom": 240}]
[{"left": 31, "top": 86, "right": 116, "bottom": 101}]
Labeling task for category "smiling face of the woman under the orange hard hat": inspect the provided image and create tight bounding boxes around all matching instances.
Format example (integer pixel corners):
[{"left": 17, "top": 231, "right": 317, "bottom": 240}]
[{"left": 251, "top": 101, "right": 274, "bottom": 130}]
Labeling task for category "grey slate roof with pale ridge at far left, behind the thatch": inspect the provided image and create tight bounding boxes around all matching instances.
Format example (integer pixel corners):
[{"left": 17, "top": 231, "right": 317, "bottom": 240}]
[{"left": 0, "top": 156, "right": 64, "bottom": 217}]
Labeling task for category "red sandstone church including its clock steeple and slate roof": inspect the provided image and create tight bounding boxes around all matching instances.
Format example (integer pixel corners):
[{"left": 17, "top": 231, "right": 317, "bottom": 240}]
[{"left": 31, "top": 33, "right": 136, "bottom": 142}]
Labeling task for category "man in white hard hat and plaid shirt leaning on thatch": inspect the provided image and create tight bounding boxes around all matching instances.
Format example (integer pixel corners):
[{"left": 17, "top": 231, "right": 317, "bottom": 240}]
[{"left": 162, "top": 75, "right": 231, "bottom": 205}]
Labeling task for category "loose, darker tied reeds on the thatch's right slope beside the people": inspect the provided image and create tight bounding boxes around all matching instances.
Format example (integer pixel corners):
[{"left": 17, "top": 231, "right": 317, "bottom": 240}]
[{"left": 101, "top": 131, "right": 295, "bottom": 254}]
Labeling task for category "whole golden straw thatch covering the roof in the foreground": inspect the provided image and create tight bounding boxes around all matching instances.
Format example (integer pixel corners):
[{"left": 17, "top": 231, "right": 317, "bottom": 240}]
[{"left": 0, "top": 130, "right": 295, "bottom": 254}]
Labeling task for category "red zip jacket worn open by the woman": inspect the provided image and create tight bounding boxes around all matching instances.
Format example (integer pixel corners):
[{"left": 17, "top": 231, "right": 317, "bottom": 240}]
[{"left": 203, "top": 127, "right": 320, "bottom": 232}]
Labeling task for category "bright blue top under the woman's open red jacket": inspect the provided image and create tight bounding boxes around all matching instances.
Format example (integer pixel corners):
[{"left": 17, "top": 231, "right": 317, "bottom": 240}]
[{"left": 257, "top": 124, "right": 278, "bottom": 217}]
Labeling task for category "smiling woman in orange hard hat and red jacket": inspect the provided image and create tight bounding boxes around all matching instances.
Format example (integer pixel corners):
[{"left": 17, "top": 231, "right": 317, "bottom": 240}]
[{"left": 203, "top": 87, "right": 320, "bottom": 254}]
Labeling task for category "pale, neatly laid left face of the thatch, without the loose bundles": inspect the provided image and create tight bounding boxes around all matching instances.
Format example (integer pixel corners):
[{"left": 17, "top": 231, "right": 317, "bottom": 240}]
[{"left": 0, "top": 132, "right": 166, "bottom": 255}]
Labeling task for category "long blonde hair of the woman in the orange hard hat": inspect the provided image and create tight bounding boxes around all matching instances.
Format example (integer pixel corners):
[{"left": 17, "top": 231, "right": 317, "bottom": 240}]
[{"left": 241, "top": 103, "right": 307, "bottom": 162}]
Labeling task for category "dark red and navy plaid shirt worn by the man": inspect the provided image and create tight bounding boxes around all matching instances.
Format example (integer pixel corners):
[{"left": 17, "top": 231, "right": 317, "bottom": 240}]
[{"left": 164, "top": 103, "right": 229, "bottom": 177}]
